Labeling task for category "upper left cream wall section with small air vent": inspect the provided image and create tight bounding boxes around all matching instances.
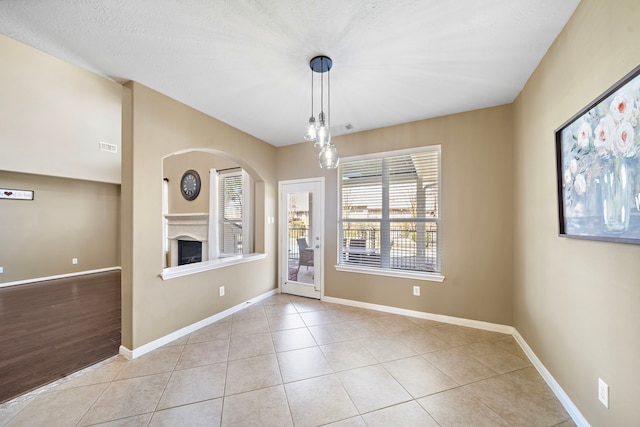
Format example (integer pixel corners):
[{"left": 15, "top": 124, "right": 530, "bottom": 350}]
[{"left": 0, "top": 34, "right": 122, "bottom": 184}]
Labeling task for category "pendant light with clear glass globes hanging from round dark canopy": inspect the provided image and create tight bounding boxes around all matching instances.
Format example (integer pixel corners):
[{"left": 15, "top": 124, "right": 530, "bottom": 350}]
[{"left": 304, "top": 55, "right": 340, "bottom": 169}]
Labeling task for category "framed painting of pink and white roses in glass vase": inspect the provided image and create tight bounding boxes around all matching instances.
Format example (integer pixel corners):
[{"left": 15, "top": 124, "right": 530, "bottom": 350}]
[{"left": 556, "top": 66, "right": 640, "bottom": 244}]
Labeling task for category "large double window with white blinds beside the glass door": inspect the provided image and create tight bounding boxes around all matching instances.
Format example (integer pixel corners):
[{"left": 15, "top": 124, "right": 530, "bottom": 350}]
[{"left": 338, "top": 146, "right": 441, "bottom": 274}]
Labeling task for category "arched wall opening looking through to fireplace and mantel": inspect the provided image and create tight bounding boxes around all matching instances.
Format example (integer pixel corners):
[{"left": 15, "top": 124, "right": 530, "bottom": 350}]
[{"left": 162, "top": 149, "right": 265, "bottom": 271}]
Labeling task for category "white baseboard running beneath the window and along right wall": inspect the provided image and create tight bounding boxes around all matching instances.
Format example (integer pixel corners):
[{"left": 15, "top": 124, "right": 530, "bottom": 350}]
[{"left": 322, "top": 297, "right": 591, "bottom": 427}]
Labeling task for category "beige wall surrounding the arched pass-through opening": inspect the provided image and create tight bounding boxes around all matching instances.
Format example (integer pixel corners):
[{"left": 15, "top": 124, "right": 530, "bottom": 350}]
[{"left": 122, "top": 83, "right": 277, "bottom": 349}]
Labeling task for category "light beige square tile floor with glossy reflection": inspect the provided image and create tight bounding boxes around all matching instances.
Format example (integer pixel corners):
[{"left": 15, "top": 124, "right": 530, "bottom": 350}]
[{"left": 0, "top": 295, "right": 575, "bottom": 427}]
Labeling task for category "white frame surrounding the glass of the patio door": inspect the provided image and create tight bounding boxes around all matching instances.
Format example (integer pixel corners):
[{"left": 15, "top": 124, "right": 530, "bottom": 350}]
[{"left": 278, "top": 177, "right": 325, "bottom": 299}]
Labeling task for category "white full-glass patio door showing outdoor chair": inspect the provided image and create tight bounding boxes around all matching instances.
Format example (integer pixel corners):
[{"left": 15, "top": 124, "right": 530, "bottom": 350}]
[{"left": 280, "top": 179, "right": 324, "bottom": 299}]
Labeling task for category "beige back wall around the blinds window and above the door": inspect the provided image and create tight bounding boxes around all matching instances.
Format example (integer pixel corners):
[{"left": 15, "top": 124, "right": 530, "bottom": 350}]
[{"left": 278, "top": 106, "right": 513, "bottom": 325}]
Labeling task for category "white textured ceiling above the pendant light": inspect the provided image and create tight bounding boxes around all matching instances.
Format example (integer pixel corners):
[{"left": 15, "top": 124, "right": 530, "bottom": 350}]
[{"left": 0, "top": 0, "right": 579, "bottom": 146}]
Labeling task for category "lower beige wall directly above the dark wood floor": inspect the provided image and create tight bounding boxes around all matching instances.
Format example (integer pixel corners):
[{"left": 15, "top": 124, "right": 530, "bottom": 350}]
[{"left": 0, "top": 171, "right": 120, "bottom": 284}]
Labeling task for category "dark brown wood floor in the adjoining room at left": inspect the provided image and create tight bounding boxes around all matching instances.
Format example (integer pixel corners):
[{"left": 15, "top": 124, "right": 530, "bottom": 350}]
[{"left": 0, "top": 270, "right": 120, "bottom": 403}]
